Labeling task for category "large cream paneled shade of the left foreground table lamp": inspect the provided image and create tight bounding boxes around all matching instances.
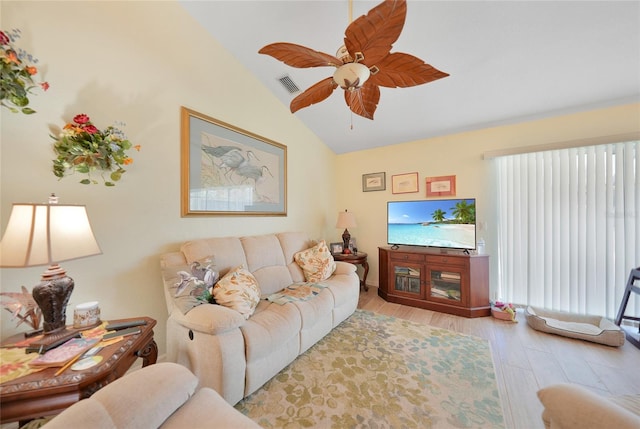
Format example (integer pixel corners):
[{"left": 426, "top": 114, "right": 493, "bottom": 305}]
[{"left": 0, "top": 203, "right": 102, "bottom": 267}]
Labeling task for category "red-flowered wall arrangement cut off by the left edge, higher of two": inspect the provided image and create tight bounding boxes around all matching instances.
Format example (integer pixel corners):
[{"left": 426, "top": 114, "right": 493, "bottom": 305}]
[{"left": 0, "top": 29, "right": 49, "bottom": 115}]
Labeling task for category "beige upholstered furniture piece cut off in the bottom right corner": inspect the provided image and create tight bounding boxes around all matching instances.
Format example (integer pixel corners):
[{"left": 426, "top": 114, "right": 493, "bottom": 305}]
[{"left": 538, "top": 383, "right": 640, "bottom": 429}]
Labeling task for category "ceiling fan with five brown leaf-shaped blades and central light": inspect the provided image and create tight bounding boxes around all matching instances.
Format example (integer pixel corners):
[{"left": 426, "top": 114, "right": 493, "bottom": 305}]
[{"left": 258, "top": 0, "right": 449, "bottom": 119}]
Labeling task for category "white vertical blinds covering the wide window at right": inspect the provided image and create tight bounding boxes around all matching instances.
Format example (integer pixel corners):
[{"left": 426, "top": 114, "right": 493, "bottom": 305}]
[{"left": 495, "top": 141, "right": 640, "bottom": 318}]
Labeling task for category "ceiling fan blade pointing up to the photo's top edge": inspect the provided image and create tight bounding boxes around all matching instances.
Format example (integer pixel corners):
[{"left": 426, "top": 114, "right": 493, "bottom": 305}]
[{"left": 344, "top": 0, "right": 407, "bottom": 67}]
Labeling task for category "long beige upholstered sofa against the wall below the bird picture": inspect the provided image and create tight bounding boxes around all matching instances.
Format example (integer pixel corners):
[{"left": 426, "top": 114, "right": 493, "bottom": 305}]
[{"left": 161, "top": 232, "right": 360, "bottom": 404}]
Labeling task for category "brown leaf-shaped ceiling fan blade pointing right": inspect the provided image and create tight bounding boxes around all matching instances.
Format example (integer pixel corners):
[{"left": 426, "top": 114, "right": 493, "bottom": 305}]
[{"left": 369, "top": 52, "right": 449, "bottom": 88}]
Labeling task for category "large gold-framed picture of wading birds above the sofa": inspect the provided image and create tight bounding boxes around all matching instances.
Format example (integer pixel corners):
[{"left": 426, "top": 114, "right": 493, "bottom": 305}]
[{"left": 180, "top": 107, "right": 287, "bottom": 217}]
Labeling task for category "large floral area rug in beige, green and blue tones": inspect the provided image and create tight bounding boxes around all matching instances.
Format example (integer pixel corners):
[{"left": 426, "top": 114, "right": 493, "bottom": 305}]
[{"left": 235, "top": 310, "right": 504, "bottom": 429}]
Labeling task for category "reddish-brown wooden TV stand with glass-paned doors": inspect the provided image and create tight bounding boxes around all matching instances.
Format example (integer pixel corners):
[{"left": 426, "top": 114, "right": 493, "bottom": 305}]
[{"left": 378, "top": 247, "right": 491, "bottom": 317}]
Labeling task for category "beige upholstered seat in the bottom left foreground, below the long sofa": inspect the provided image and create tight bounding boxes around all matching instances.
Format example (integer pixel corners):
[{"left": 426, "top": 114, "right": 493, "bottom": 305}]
[{"left": 43, "top": 362, "right": 260, "bottom": 429}]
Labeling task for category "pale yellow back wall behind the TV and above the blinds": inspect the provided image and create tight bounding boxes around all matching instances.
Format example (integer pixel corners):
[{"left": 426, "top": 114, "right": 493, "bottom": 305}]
[{"left": 335, "top": 104, "right": 640, "bottom": 298}]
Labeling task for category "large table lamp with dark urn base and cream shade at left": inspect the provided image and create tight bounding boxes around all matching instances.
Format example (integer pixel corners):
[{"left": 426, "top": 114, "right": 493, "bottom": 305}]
[{"left": 0, "top": 194, "right": 102, "bottom": 337}]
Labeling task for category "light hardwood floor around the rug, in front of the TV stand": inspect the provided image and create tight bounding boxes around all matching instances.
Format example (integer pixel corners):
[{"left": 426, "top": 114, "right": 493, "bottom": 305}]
[{"left": 358, "top": 286, "right": 640, "bottom": 429}]
